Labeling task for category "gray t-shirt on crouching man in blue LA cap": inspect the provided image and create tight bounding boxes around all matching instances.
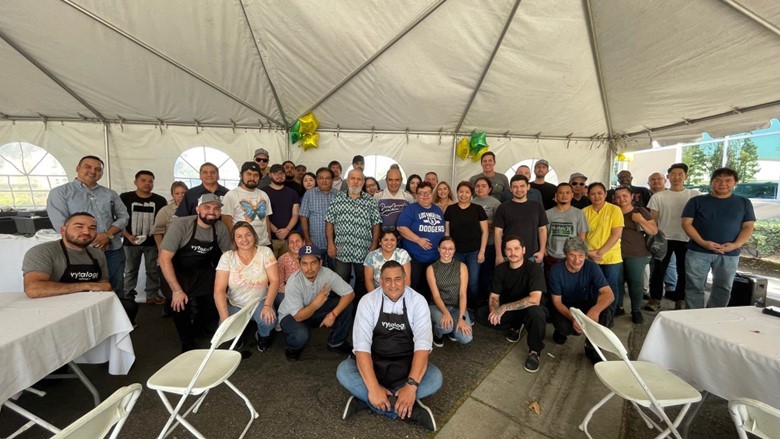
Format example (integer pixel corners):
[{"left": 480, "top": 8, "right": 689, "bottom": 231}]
[{"left": 279, "top": 267, "right": 352, "bottom": 321}]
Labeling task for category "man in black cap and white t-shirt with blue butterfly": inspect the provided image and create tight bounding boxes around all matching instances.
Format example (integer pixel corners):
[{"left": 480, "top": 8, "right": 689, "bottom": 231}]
[{"left": 222, "top": 162, "right": 274, "bottom": 248}]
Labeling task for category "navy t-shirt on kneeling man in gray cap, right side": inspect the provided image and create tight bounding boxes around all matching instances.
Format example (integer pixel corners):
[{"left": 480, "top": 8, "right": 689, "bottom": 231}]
[{"left": 550, "top": 259, "right": 609, "bottom": 307}]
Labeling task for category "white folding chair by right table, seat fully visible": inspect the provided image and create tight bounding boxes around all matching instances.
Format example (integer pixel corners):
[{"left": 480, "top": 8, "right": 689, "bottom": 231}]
[{"left": 569, "top": 307, "right": 701, "bottom": 439}]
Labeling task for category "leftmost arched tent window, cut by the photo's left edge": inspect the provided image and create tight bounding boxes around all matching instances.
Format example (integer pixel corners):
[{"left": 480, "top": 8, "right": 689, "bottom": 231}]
[{"left": 0, "top": 142, "right": 68, "bottom": 209}]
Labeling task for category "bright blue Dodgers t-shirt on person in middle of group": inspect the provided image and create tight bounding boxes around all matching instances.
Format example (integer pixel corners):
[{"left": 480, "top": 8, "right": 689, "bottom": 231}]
[{"left": 396, "top": 203, "right": 444, "bottom": 264}]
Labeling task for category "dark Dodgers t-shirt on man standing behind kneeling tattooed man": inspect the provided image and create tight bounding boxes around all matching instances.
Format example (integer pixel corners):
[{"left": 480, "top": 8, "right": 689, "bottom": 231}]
[{"left": 494, "top": 201, "right": 548, "bottom": 256}]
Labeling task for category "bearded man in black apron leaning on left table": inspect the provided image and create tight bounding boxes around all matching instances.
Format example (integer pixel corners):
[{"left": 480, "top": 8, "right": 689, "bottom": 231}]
[{"left": 22, "top": 212, "right": 113, "bottom": 298}]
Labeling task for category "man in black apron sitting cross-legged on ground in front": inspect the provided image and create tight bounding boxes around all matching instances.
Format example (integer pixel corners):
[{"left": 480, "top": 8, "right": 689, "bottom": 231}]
[{"left": 336, "top": 261, "right": 442, "bottom": 431}]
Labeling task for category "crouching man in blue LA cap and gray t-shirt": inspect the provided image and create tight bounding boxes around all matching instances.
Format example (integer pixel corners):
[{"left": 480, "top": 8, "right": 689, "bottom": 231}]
[{"left": 279, "top": 245, "right": 355, "bottom": 361}]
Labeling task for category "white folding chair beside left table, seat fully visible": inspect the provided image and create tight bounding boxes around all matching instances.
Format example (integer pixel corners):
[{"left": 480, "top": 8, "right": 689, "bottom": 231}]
[{"left": 146, "top": 298, "right": 260, "bottom": 439}]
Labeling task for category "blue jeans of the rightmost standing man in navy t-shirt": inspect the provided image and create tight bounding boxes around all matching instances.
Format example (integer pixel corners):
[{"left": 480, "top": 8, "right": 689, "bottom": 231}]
[{"left": 685, "top": 250, "right": 739, "bottom": 309}]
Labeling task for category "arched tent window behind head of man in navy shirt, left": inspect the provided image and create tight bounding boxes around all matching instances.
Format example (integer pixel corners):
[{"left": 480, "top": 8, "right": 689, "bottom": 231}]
[{"left": 173, "top": 146, "right": 240, "bottom": 189}]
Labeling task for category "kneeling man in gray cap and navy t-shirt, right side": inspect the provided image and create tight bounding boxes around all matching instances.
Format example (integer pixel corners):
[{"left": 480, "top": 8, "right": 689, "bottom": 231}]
[{"left": 550, "top": 236, "right": 615, "bottom": 363}]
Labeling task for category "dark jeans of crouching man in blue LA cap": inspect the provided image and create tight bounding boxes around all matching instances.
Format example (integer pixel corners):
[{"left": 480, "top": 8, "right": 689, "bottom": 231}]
[{"left": 279, "top": 295, "right": 352, "bottom": 351}]
